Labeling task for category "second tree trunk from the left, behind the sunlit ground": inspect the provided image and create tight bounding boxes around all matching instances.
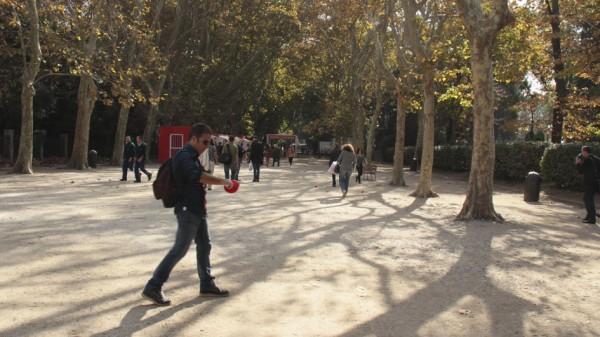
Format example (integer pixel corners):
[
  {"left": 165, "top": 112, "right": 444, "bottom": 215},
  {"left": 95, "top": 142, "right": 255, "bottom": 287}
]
[{"left": 68, "top": 74, "right": 98, "bottom": 170}]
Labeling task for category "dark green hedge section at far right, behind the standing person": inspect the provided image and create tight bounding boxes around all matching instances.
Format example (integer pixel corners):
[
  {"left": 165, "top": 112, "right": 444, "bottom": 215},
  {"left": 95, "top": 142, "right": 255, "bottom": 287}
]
[{"left": 540, "top": 143, "right": 600, "bottom": 190}]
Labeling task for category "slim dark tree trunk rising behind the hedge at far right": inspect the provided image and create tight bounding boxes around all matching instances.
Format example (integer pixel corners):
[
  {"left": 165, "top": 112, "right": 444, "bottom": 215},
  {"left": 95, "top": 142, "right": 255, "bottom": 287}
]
[{"left": 547, "top": 0, "right": 569, "bottom": 143}]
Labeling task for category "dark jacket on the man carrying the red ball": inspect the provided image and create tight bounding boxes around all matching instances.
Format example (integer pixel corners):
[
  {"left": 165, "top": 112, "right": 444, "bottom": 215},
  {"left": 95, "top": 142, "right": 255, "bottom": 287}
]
[{"left": 172, "top": 144, "right": 206, "bottom": 216}]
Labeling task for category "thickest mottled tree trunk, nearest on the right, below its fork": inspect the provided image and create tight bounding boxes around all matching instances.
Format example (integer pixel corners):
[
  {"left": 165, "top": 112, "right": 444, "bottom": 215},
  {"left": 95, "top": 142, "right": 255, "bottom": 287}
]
[{"left": 457, "top": 37, "right": 503, "bottom": 221}]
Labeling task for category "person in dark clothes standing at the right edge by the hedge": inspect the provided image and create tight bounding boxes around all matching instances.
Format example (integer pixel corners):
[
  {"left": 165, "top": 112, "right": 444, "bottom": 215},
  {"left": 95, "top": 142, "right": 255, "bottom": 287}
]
[{"left": 575, "top": 146, "right": 600, "bottom": 224}]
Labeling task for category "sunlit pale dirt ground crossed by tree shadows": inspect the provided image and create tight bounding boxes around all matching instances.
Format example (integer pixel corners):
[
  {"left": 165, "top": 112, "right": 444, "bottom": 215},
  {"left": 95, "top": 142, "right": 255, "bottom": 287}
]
[{"left": 0, "top": 159, "right": 600, "bottom": 337}]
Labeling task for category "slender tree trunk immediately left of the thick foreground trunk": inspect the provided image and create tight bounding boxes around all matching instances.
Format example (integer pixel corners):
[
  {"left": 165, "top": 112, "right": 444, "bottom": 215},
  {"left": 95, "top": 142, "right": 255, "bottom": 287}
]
[{"left": 411, "top": 65, "right": 438, "bottom": 198}]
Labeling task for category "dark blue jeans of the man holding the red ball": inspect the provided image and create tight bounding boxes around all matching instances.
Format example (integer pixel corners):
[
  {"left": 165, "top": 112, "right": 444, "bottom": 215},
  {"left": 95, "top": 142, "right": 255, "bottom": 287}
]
[{"left": 148, "top": 211, "right": 213, "bottom": 289}]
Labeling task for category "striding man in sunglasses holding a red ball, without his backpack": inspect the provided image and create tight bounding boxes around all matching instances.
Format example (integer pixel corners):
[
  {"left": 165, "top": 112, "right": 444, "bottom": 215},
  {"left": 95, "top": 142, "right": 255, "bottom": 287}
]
[{"left": 142, "top": 124, "right": 232, "bottom": 305}]
